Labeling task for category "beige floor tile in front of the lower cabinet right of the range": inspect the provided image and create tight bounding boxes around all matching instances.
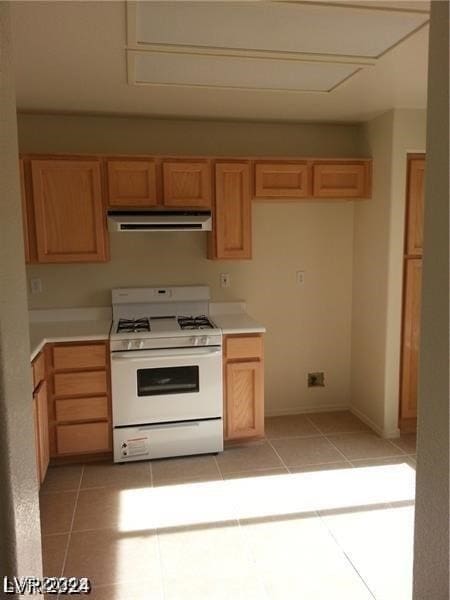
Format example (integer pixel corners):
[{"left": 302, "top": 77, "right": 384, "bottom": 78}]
[{"left": 217, "top": 442, "right": 282, "bottom": 474}]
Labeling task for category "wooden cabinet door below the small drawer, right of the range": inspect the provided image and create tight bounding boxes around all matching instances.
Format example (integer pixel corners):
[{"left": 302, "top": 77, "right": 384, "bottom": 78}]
[{"left": 225, "top": 361, "right": 264, "bottom": 439}]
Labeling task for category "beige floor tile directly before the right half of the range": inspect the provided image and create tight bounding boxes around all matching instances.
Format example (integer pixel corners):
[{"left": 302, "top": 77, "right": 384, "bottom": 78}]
[{"left": 152, "top": 455, "right": 220, "bottom": 485}]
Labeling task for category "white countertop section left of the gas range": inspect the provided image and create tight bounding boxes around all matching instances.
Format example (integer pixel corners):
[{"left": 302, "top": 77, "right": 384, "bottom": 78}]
[{"left": 30, "top": 320, "right": 111, "bottom": 360}]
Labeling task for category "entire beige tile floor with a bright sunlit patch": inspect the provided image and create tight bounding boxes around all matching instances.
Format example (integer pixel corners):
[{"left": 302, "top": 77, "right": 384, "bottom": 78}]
[{"left": 41, "top": 412, "right": 415, "bottom": 600}]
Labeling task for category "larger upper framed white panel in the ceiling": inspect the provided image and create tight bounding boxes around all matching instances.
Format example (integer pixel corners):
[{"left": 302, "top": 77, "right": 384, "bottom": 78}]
[{"left": 128, "top": 1, "right": 429, "bottom": 59}]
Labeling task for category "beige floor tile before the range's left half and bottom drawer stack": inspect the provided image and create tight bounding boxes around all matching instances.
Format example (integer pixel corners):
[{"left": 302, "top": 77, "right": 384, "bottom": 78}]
[{"left": 81, "top": 461, "right": 151, "bottom": 489}]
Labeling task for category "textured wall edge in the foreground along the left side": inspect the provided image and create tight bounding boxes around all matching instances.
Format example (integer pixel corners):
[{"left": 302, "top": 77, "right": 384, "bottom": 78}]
[{"left": 0, "top": 2, "right": 42, "bottom": 576}]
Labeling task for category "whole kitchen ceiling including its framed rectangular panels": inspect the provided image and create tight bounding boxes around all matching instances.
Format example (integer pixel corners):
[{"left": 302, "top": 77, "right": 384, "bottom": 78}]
[{"left": 11, "top": 0, "right": 429, "bottom": 122}]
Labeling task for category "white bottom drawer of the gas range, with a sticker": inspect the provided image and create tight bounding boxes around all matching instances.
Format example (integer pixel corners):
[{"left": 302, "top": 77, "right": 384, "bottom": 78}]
[{"left": 113, "top": 419, "right": 223, "bottom": 462}]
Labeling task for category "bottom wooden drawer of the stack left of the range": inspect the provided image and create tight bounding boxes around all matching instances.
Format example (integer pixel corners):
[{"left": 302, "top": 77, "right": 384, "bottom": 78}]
[{"left": 56, "top": 423, "right": 110, "bottom": 454}]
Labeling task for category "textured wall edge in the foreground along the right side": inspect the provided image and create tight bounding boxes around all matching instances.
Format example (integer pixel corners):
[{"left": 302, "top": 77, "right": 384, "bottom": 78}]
[{"left": 414, "top": 2, "right": 449, "bottom": 600}]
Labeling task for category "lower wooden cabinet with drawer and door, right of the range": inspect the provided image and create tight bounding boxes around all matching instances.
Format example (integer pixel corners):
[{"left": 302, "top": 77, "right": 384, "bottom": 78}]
[{"left": 224, "top": 335, "right": 264, "bottom": 440}]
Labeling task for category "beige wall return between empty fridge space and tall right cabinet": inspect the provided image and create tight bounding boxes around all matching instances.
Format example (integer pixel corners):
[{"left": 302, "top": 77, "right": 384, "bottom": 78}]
[{"left": 351, "top": 110, "right": 426, "bottom": 437}]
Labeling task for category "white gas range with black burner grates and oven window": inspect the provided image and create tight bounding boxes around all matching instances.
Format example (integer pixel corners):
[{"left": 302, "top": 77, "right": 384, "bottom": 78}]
[{"left": 110, "top": 286, "right": 223, "bottom": 462}]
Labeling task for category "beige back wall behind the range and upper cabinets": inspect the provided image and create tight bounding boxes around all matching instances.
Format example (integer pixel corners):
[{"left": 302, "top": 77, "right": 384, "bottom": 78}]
[{"left": 19, "top": 115, "right": 366, "bottom": 413}]
